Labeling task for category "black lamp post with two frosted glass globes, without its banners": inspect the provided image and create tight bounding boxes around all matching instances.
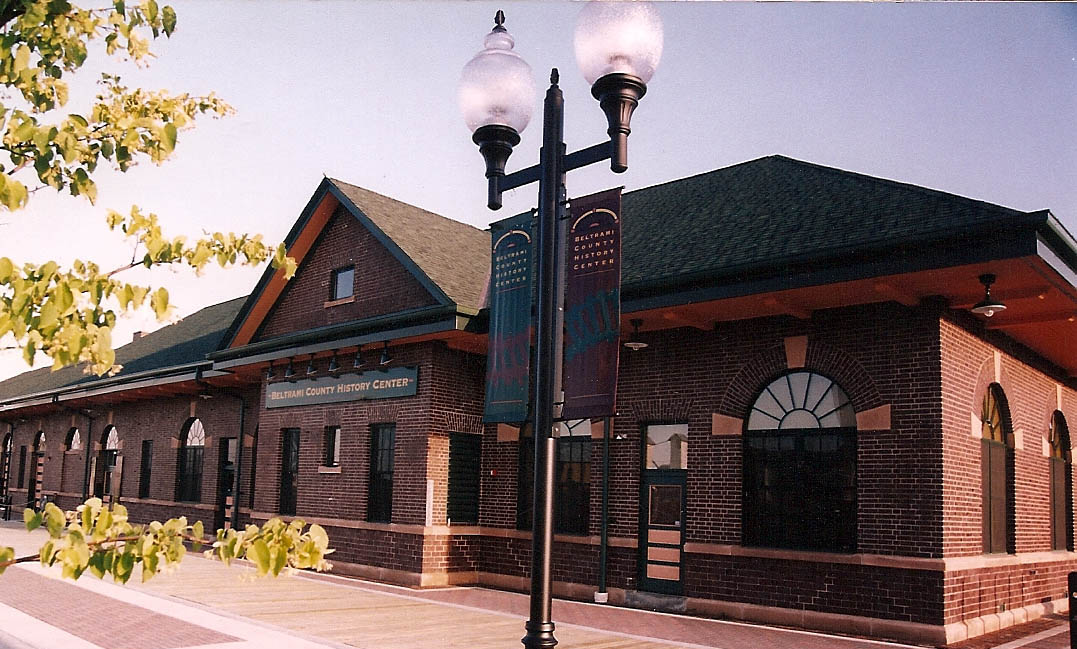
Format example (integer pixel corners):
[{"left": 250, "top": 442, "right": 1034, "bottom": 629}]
[{"left": 460, "top": 2, "right": 662, "bottom": 649}]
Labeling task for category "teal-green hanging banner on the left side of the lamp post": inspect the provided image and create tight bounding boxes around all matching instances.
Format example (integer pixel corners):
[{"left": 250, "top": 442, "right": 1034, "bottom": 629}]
[{"left": 484, "top": 213, "right": 532, "bottom": 423}]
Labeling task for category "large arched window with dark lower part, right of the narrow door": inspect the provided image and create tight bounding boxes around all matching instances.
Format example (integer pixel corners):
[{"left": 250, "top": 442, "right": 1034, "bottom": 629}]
[{"left": 742, "top": 370, "right": 856, "bottom": 552}]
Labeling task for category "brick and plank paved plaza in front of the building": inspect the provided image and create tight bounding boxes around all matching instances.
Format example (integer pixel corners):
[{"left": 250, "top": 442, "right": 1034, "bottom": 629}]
[{"left": 0, "top": 523, "right": 1068, "bottom": 649}]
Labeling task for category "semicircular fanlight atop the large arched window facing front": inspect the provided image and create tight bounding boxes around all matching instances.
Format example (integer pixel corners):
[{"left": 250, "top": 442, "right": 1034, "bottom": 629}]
[{"left": 747, "top": 371, "right": 856, "bottom": 431}]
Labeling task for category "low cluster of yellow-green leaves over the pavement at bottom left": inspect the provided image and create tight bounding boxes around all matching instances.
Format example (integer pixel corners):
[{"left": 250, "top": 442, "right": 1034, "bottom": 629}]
[{"left": 0, "top": 498, "right": 333, "bottom": 583}]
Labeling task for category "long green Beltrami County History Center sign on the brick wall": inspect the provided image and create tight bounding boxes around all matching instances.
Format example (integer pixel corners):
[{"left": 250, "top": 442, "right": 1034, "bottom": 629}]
[{"left": 266, "top": 367, "right": 419, "bottom": 408}]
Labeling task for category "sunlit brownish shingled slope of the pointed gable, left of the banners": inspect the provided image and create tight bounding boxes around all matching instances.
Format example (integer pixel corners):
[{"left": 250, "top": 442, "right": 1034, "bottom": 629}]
[{"left": 328, "top": 178, "right": 490, "bottom": 310}]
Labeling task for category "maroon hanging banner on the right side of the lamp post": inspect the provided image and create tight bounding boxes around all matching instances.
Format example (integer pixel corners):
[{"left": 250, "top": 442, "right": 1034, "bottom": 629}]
[{"left": 561, "top": 188, "right": 620, "bottom": 420}]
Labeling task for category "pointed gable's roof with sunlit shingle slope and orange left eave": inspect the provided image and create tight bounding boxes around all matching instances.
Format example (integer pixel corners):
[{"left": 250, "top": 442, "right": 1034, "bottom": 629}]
[{"left": 220, "top": 178, "right": 490, "bottom": 350}]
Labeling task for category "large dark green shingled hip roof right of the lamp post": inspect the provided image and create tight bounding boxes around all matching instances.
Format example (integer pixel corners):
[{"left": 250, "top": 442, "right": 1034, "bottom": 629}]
[{"left": 621, "top": 155, "right": 1046, "bottom": 284}]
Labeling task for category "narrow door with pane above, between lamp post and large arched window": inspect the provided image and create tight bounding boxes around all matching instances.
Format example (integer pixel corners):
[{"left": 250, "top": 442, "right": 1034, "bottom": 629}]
[{"left": 639, "top": 424, "right": 688, "bottom": 595}]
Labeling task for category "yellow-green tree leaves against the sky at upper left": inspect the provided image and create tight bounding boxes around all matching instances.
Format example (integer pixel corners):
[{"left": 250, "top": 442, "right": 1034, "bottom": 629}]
[{"left": 0, "top": 0, "right": 295, "bottom": 375}]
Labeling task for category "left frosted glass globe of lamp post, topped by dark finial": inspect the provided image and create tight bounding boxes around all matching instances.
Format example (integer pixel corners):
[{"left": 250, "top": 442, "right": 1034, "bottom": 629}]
[{"left": 458, "top": 12, "right": 535, "bottom": 133}]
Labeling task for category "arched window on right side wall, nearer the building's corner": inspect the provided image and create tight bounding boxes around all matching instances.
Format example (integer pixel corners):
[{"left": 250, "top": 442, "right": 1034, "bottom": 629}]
[{"left": 980, "top": 383, "right": 1015, "bottom": 553}]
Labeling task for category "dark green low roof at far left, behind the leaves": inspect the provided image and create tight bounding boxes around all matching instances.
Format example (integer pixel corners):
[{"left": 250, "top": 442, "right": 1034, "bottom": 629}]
[{"left": 0, "top": 297, "right": 246, "bottom": 401}]
